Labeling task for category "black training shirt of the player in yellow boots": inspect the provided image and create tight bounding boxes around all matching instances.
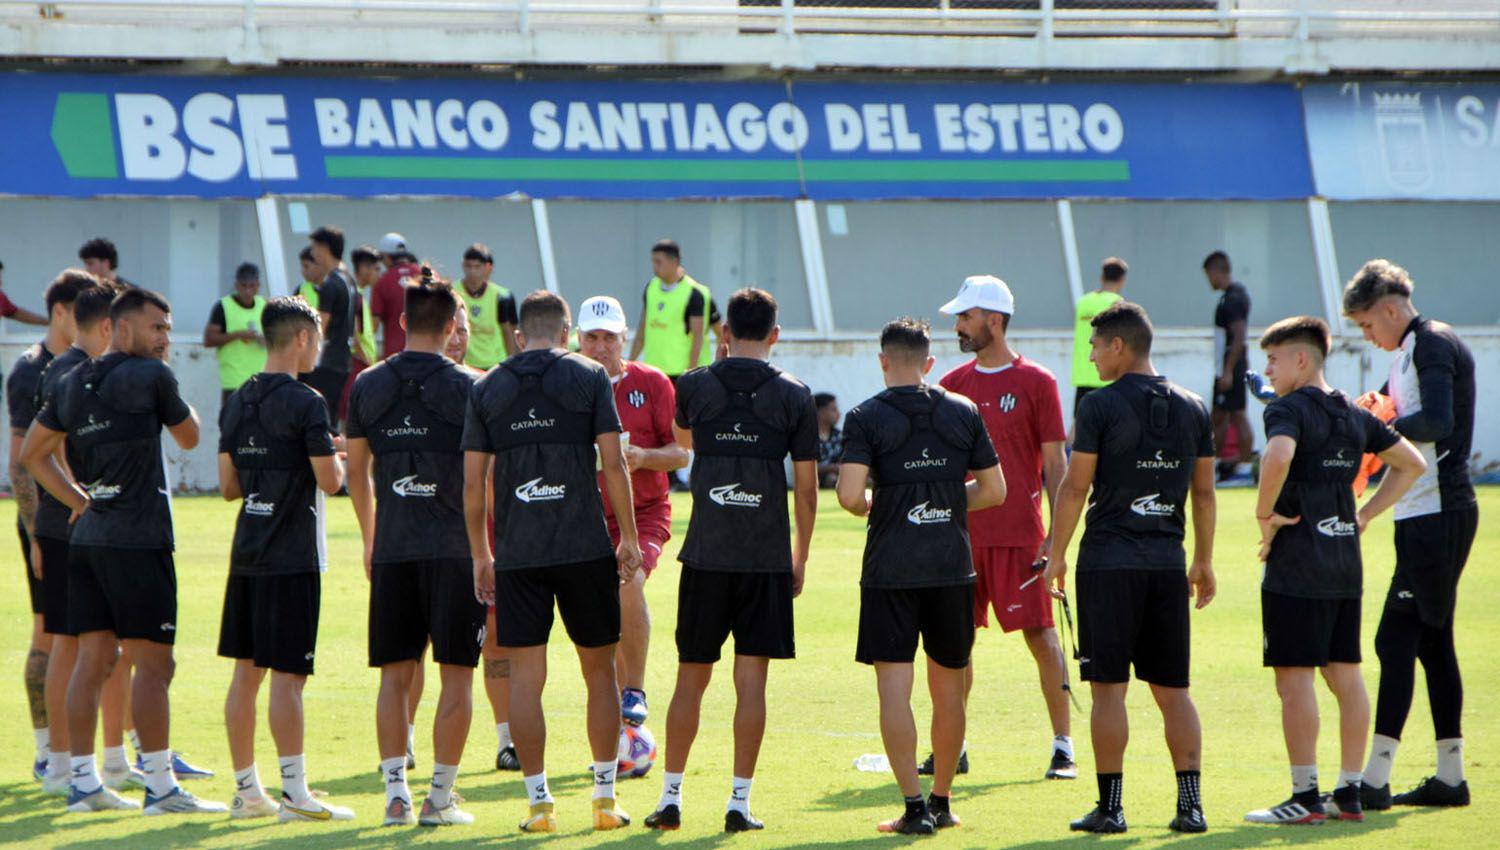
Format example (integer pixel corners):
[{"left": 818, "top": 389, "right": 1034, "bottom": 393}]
[{"left": 464, "top": 349, "right": 620, "bottom": 570}]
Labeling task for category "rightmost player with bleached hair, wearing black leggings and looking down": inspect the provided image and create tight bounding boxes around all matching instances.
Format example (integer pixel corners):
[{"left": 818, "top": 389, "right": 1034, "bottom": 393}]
[{"left": 1344, "top": 259, "right": 1479, "bottom": 810}]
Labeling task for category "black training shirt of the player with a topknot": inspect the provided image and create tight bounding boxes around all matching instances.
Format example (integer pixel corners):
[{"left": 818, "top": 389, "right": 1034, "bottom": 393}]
[{"left": 345, "top": 351, "right": 476, "bottom": 564}]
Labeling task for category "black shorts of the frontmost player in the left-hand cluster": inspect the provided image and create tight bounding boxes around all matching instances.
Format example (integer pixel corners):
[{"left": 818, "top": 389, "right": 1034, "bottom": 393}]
[{"left": 67, "top": 544, "right": 177, "bottom": 645}]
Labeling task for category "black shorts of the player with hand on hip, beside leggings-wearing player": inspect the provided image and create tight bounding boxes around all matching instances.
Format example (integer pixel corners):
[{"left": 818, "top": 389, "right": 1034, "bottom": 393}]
[{"left": 1260, "top": 591, "right": 1359, "bottom": 667}]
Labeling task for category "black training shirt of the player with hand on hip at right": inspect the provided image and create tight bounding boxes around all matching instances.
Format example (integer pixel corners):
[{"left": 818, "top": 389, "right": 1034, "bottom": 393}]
[{"left": 1262, "top": 387, "right": 1401, "bottom": 600}]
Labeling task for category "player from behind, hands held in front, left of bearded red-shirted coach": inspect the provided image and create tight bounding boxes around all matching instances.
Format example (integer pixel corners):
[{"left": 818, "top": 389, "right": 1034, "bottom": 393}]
[{"left": 839, "top": 319, "right": 1005, "bottom": 835}]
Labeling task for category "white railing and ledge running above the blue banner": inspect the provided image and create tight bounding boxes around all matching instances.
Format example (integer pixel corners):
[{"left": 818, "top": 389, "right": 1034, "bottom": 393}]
[{"left": 0, "top": 0, "right": 1500, "bottom": 73}]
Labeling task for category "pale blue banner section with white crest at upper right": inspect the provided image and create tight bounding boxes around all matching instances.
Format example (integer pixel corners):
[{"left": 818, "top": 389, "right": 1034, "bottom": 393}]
[{"left": 1302, "top": 82, "right": 1500, "bottom": 201}]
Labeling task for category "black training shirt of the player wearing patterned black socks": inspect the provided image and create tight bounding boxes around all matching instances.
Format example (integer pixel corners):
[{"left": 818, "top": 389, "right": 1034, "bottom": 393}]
[{"left": 1073, "top": 373, "right": 1214, "bottom": 573}]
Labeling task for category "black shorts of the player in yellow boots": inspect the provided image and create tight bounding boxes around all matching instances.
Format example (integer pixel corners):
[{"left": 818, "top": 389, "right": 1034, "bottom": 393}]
[{"left": 495, "top": 555, "right": 620, "bottom": 648}]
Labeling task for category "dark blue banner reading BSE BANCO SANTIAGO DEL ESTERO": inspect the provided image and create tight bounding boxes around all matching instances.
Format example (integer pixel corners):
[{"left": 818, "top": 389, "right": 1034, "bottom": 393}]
[{"left": 0, "top": 73, "right": 1311, "bottom": 199}]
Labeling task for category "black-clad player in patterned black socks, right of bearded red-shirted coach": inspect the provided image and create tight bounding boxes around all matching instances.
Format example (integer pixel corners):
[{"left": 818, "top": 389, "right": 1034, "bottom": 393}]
[{"left": 1044, "top": 301, "right": 1215, "bottom": 832}]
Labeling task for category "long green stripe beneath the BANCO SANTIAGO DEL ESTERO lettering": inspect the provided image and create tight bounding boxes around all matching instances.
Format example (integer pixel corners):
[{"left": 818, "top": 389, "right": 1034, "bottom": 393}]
[{"left": 323, "top": 156, "right": 1130, "bottom": 183}]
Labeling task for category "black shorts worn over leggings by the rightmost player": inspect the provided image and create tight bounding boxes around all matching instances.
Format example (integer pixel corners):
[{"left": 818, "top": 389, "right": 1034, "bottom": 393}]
[{"left": 1386, "top": 507, "right": 1479, "bottom": 628}]
